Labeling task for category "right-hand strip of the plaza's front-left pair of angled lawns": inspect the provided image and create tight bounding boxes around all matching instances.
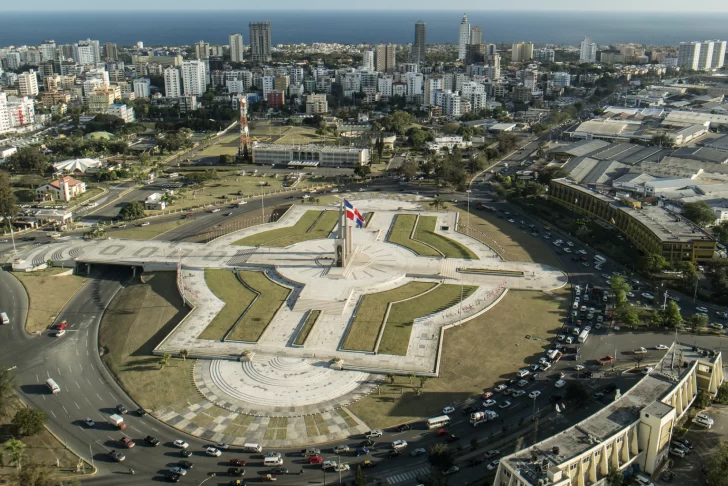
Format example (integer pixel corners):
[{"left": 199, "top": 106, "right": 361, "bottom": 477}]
[{"left": 228, "top": 270, "right": 291, "bottom": 341}]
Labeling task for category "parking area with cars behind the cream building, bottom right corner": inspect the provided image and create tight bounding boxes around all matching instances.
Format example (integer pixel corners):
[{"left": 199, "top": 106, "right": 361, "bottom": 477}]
[{"left": 655, "top": 405, "right": 728, "bottom": 486}]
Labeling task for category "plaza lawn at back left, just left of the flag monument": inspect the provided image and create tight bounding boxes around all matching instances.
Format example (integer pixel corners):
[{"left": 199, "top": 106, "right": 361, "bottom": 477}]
[{"left": 233, "top": 210, "right": 339, "bottom": 247}]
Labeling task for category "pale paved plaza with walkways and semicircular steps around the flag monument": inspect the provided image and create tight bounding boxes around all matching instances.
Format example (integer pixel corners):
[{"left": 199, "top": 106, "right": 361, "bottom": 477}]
[{"left": 13, "top": 199, "right": 567, "bottom": 446}]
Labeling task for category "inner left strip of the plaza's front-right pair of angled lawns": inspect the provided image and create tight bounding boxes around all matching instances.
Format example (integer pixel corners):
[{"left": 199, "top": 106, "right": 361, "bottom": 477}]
[{"left": 343, "top": 282, "right": 436, "bottom": 351}]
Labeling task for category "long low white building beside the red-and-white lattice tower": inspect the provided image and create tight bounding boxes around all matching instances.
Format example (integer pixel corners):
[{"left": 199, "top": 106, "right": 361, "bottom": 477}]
[{"left": 253, "top": 144, "right": 369, "bottom": 167}]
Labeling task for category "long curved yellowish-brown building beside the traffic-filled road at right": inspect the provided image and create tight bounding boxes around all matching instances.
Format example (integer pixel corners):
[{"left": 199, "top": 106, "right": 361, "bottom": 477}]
[{"left": 549, "top": 179, "right": 716, "bottom": 264}]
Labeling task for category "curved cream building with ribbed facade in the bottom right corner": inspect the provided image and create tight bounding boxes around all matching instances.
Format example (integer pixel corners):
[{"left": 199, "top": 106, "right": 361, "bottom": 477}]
[{"left": 493, "top": 344, "right": 723, "bottom": 486}]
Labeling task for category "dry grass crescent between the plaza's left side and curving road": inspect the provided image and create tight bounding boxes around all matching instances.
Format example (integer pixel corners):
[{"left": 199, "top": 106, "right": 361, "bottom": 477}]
[{"left": 99, "top": 272, "right": 199, "bottom": 411}]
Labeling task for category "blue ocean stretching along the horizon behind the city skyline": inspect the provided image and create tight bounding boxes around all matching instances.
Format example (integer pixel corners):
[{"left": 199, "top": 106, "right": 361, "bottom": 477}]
[{"left": 0, "top": 10, "right": 728, "bottom": 47}]
